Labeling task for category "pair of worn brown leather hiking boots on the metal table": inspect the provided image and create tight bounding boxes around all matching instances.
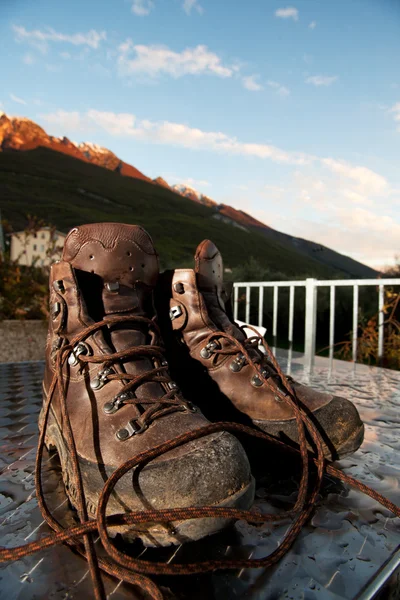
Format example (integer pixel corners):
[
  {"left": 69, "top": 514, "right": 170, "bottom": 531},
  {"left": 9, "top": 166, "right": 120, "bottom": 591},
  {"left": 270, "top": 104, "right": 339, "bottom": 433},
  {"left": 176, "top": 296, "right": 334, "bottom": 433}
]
[{"left": 39, "top": 223, "right": 364, "bottom": 546}]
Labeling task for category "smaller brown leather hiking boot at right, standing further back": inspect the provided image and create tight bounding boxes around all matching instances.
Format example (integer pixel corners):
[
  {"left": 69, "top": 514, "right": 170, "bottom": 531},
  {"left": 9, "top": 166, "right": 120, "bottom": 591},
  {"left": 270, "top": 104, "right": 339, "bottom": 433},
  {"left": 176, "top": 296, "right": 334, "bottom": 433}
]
[{"left": 157, "top": 240, "right": 364, "bottom": 460}]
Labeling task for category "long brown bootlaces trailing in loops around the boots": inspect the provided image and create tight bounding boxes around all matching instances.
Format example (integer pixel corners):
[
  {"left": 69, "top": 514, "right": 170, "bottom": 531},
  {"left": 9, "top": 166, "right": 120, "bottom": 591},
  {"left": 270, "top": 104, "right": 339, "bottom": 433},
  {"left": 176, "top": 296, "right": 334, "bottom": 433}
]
[{"left": 0, "top": 316, "right": 400, "bottom": 600}]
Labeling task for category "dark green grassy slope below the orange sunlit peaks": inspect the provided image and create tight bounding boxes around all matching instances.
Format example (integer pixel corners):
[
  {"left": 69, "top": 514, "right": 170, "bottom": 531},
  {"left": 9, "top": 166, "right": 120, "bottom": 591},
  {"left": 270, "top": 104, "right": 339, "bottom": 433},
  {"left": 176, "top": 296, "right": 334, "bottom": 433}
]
[{"left": 0, "top": 148, "right": 342, "bottom": 278}]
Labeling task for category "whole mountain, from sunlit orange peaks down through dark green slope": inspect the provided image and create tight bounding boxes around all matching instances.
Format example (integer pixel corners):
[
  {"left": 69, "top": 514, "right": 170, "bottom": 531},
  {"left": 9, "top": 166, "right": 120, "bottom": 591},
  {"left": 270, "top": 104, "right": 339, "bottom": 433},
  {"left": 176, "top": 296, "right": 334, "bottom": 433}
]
[{"left": 0, "top": 113, "right": 377, "bottom": 278}]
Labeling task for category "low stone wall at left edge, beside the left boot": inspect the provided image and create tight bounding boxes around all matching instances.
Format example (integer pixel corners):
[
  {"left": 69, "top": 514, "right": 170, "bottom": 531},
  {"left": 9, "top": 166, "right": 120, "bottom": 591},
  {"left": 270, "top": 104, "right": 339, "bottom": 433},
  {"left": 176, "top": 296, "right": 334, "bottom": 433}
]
[{"left": 0, "top": 321, "right": 47, "bottom": 363}]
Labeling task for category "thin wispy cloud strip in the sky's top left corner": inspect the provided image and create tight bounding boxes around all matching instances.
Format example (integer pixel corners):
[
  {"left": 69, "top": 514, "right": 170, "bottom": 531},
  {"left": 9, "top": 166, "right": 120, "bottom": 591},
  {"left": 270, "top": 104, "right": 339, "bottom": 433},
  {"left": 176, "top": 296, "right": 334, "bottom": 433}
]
[{"left": 12, "top": 25, "right": 107, "bottom": 53}]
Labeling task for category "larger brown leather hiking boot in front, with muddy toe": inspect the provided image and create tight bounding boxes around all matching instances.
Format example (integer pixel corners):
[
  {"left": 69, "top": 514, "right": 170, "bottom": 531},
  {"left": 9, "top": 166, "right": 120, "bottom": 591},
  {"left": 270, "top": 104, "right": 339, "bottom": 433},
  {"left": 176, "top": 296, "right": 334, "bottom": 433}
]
[{"left": 40, "top": 223, "right": 254, "bottom": 546}]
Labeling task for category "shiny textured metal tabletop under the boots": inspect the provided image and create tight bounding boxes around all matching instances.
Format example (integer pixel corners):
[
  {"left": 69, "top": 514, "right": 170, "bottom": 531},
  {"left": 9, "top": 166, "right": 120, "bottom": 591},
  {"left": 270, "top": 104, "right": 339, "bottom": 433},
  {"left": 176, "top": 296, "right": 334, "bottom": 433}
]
[{"left": 0, "top": 359, "right": 400, "bottom": 600}]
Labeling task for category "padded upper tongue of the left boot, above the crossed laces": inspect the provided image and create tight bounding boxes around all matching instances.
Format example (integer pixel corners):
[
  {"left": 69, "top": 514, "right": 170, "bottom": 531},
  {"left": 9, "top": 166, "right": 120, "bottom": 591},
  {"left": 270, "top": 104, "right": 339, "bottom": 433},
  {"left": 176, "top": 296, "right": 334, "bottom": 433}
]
[{"left": 63, "top": 223, "right": 159, "bottom": 315}]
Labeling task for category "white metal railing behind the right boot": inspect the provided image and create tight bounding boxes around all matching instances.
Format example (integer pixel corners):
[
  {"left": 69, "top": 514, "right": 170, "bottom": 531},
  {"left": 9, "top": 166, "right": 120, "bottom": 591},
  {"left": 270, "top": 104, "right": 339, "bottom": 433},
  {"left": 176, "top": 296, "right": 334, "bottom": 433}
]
[{"left": 233, "top": 278, "right": 400, "bottom": 372}]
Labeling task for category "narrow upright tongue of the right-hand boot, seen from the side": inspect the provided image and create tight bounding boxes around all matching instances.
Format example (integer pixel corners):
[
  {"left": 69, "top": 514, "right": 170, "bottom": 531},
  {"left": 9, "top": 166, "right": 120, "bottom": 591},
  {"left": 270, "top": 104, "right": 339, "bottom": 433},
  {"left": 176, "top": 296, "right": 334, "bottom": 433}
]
[{"left": 194, "top": 240, "right": 246, "bottom": 342}]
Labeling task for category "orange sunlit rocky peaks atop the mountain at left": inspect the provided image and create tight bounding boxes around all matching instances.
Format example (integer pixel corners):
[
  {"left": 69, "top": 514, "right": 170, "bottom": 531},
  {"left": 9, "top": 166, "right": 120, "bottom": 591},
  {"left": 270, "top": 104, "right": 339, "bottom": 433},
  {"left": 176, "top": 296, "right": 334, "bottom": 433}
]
[{"left": 0, "top": 113, "right": 151, "bottom": 181}]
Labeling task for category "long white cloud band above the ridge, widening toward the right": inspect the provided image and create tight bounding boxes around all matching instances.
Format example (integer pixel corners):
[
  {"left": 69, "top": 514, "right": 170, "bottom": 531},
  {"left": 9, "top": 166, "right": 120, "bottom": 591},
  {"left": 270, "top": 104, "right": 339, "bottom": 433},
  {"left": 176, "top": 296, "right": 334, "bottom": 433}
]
[{"left": 36, "top": 109, "right": 400, "bottom": 264}]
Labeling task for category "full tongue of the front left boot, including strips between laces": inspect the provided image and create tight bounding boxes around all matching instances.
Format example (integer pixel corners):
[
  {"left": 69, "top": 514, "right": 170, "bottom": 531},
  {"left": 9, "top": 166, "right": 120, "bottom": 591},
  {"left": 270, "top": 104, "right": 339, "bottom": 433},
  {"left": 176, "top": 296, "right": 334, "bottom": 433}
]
[{"left": 63, "top": 223, "right": 164, "bottom": 398}]
